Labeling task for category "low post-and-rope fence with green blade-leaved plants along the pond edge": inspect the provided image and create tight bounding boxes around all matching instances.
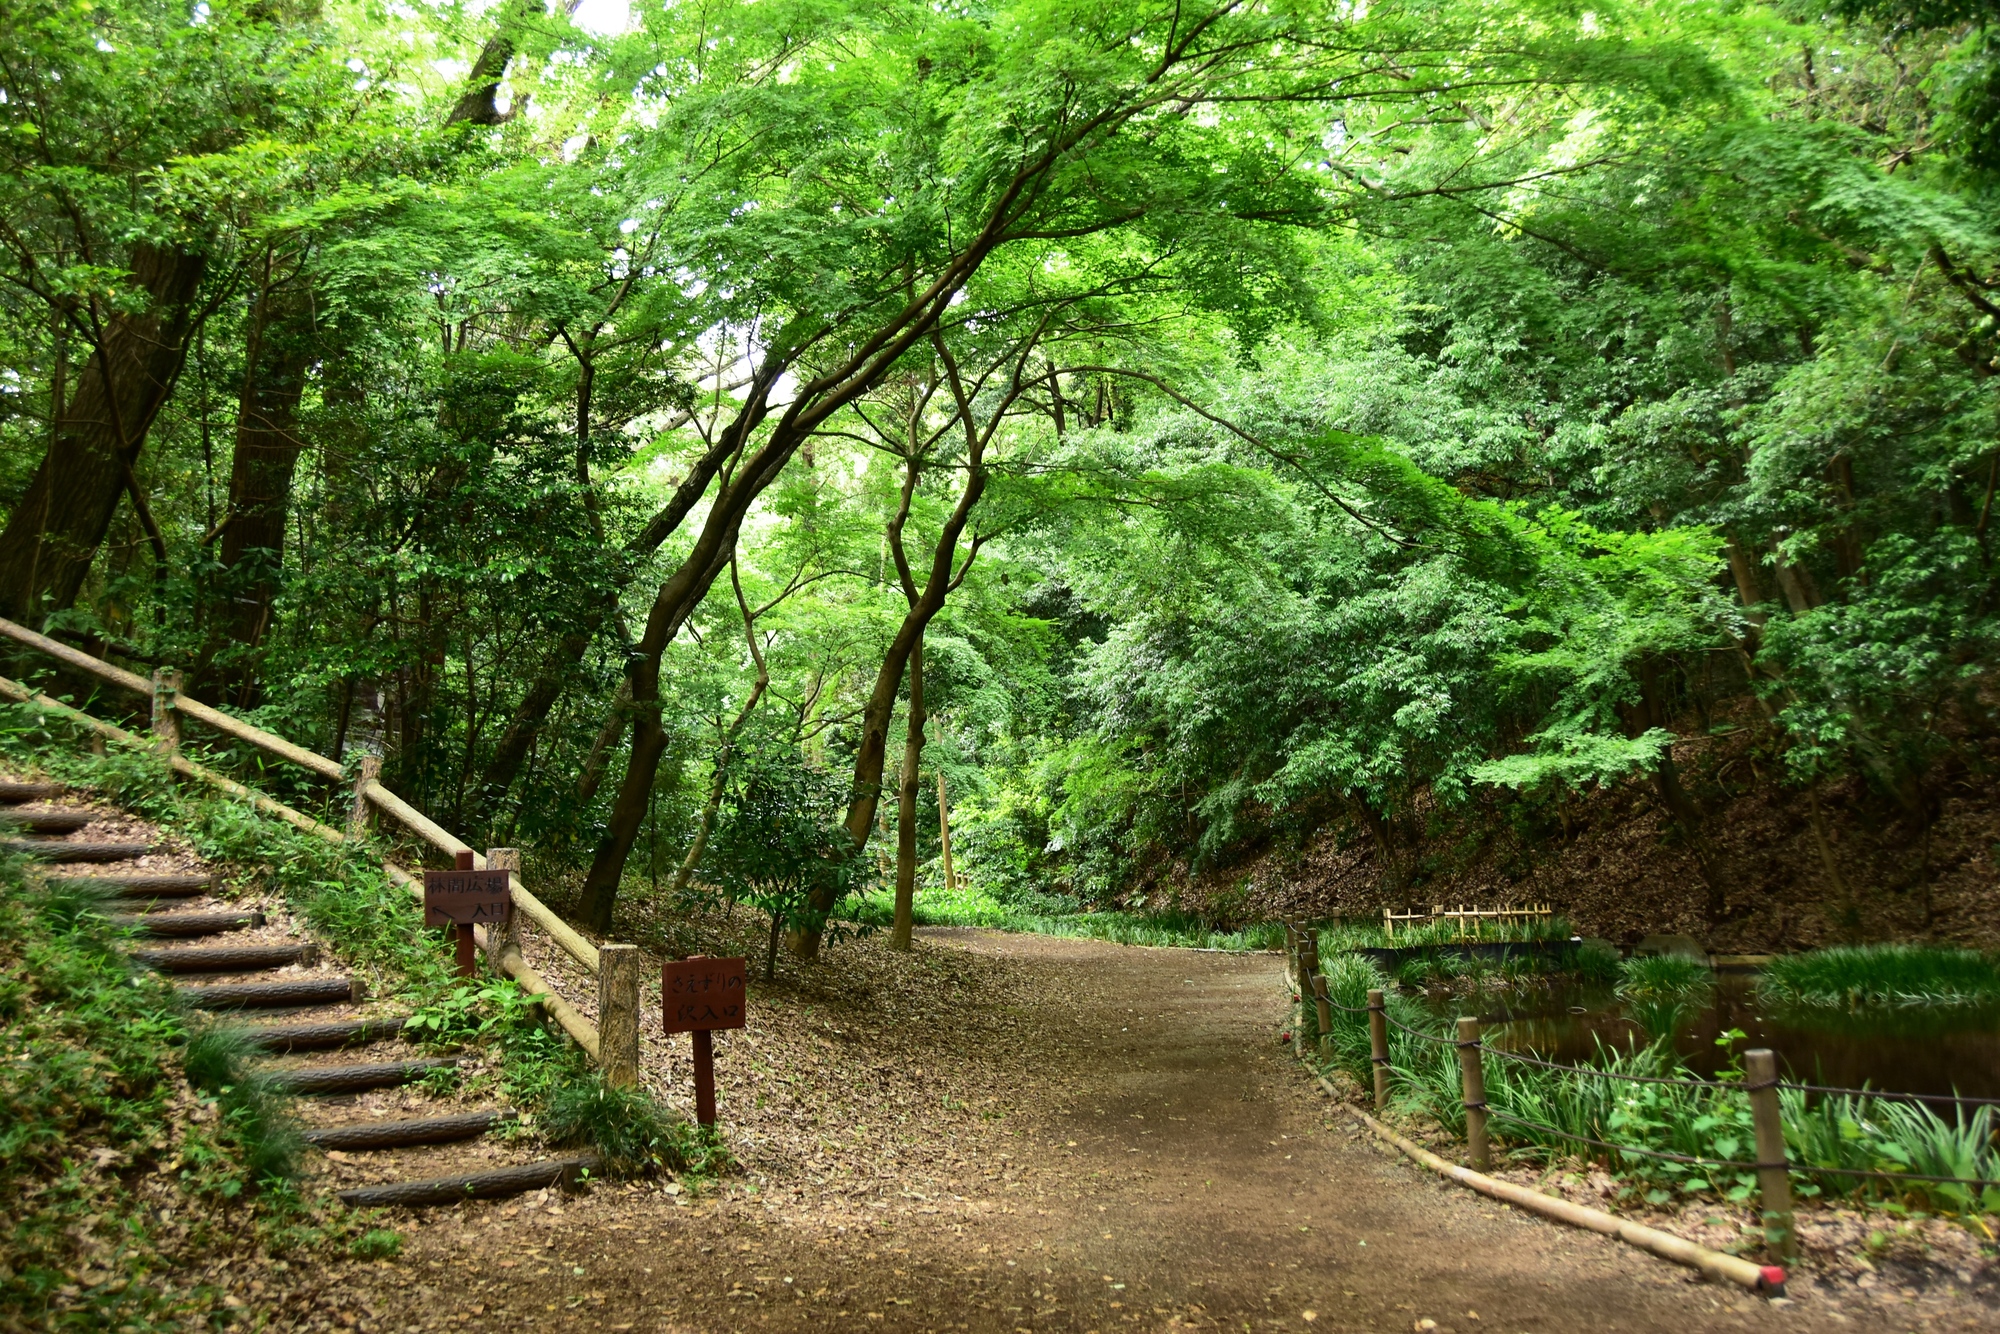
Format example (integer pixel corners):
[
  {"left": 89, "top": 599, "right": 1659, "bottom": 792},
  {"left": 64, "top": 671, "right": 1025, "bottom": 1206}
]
[{"left": 1286, "top": 928, "right": 2000, "bottom": 1258}]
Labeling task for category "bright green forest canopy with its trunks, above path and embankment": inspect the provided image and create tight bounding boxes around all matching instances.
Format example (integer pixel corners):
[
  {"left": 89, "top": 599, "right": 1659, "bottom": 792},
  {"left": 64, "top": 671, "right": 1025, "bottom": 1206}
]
[{"left": 0, "top": 0, "right": 2000, "bottom": 954}]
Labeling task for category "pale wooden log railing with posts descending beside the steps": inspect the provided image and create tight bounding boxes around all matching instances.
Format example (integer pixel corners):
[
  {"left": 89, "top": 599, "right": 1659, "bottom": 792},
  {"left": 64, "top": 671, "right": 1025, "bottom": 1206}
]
[{"left": 0, "top": 616, "right": 638, "bottom": 1082}]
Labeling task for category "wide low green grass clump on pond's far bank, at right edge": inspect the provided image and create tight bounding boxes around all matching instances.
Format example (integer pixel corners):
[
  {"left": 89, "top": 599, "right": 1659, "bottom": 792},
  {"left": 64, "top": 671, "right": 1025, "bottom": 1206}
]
[{"left": 1758, "top": 944, "right": 2000, "bottom": 1010}]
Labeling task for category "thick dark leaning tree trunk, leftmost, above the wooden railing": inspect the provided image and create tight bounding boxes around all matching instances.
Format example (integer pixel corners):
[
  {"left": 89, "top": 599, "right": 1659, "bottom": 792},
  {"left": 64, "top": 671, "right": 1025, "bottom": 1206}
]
[{"left": 0, "top": 244, "right": 206, "bottom": 626}]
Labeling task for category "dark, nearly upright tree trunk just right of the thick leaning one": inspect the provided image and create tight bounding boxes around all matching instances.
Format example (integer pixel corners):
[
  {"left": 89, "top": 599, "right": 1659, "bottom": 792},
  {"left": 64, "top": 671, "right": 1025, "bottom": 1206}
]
[{"left": 216, "top": 266, "right": 312, "bottom": 704}]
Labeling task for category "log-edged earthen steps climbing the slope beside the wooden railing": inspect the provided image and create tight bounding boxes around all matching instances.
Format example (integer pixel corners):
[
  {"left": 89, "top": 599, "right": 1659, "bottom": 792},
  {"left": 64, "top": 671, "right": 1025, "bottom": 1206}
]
[{"left": 0, "top": 780, "right": 596, "bottom": 1206}]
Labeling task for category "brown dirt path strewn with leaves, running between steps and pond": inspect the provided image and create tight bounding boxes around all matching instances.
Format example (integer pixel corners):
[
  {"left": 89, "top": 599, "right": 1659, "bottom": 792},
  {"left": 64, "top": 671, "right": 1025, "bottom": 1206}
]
[{"left": 332, "top": 932, "right": 1974, "bottom": 1334}]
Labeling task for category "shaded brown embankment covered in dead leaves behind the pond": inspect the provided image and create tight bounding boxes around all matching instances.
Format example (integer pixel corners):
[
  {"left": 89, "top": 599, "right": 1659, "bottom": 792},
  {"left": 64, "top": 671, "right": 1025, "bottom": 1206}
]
[{"left": 1156, "top": 706, "right": 2000, "bottom": 954}]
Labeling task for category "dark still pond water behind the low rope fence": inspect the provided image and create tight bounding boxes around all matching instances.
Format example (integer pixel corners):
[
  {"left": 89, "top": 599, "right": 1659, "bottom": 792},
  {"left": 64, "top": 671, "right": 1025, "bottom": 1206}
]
[{"left": 1422, "top": 974, "right": 2000, "bottom": 1098}]
